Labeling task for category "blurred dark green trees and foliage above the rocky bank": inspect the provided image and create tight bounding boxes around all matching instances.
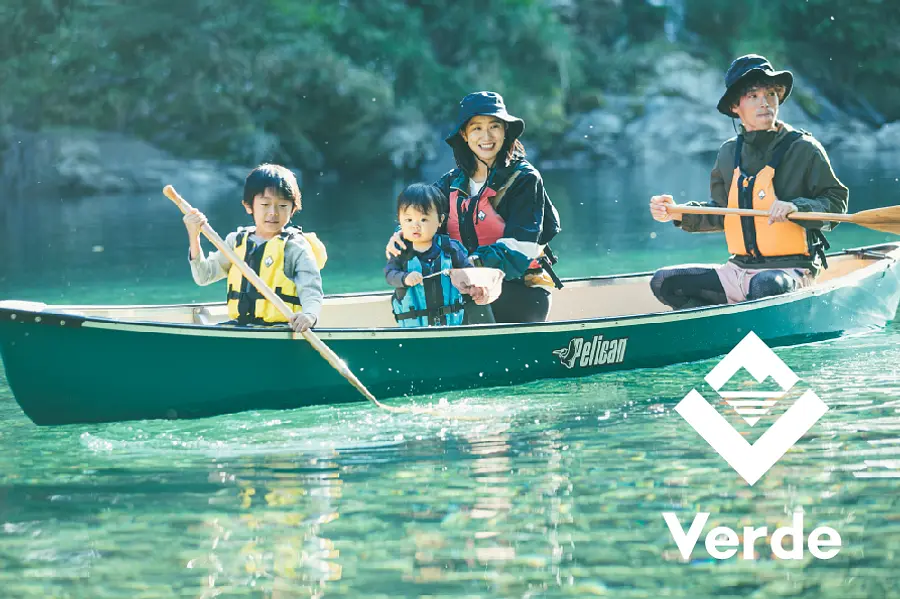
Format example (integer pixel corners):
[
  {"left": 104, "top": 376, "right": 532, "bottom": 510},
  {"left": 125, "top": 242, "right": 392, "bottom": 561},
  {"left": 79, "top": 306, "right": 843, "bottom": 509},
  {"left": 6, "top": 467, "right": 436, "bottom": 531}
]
[{"left": 0, "top": 0, "right": 900, "bottom": 170}]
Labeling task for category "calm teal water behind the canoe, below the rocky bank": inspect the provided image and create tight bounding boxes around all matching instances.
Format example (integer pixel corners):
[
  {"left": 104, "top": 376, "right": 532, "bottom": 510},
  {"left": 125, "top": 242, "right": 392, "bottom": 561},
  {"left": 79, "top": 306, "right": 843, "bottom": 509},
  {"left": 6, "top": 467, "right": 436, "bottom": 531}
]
[{"left": 0, "top": 160, "right": 900, "bottom": 303}]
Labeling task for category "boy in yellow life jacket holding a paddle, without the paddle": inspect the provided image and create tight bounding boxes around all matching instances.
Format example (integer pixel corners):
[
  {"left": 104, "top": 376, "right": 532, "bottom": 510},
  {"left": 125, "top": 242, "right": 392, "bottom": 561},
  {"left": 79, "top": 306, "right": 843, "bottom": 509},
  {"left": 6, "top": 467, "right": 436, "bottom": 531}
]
[{"left": 184, "top": 164, "right": 326, "bottom": 332}]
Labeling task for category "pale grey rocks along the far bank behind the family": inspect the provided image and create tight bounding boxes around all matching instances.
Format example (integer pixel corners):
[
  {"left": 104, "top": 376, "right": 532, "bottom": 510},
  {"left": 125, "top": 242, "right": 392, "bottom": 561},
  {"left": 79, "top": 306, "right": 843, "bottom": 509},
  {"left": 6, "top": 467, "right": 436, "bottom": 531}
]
[{"left": 0, "top": 52, "right": 900, "bottom": 197}]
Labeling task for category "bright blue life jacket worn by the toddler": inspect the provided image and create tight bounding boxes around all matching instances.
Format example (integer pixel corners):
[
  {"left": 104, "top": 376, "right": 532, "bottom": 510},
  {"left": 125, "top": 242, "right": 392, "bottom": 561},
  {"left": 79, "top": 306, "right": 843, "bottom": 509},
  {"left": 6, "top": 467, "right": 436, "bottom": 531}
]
[{"left": 391, "top": 235, "right": 463, "bottom": 328}]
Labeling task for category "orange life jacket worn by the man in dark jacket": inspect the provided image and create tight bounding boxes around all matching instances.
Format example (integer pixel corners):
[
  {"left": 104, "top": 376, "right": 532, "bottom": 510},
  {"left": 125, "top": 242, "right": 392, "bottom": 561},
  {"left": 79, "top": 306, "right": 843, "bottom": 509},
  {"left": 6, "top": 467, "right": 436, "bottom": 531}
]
[{"left": 725, "top": 131, "right": 810, "bottom": 258}]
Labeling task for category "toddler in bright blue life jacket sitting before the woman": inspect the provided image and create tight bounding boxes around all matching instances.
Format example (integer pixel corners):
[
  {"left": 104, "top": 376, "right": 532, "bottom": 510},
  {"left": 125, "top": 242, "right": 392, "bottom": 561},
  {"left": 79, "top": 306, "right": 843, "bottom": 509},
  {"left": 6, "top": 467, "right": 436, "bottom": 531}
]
[{"left": 384, "top": 183, "right": 470, "bottom": 327}]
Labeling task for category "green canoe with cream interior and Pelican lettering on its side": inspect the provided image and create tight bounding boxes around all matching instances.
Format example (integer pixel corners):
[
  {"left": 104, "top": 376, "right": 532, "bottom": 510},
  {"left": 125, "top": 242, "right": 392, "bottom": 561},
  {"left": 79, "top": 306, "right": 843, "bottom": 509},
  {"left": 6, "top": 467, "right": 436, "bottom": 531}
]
[{"left": 0, "top": 243, "right": 900, "bottom": 424}]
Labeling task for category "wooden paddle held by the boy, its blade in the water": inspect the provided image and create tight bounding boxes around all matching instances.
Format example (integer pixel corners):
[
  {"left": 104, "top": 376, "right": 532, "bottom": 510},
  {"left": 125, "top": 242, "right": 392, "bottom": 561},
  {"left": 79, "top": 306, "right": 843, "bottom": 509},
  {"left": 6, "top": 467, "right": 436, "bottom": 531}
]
[{"left": 163, "top": 185, "right": 474, "bottom": 418}]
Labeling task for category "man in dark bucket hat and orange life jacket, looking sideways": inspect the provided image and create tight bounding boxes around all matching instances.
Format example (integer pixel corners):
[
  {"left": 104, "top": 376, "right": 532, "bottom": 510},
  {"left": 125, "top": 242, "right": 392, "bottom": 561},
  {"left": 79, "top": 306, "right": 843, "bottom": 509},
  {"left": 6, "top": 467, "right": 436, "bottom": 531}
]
[{"left": 650, "top": 54, "right": 849, "bottom": 310}]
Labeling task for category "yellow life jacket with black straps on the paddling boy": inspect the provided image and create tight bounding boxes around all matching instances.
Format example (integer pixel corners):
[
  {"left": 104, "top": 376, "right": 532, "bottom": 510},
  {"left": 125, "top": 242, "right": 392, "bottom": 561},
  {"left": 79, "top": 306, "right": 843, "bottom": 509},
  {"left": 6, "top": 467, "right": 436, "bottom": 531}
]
[{"left": 227, "top": 227, "right": 328, "bottom": 323}]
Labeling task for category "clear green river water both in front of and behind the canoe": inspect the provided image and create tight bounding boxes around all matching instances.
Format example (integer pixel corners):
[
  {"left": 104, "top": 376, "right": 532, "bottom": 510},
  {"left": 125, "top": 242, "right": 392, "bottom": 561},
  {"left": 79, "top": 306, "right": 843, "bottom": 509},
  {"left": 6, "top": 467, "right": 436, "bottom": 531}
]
[{"left": 0, "top": 157, "right": 900, "bottom": 599}]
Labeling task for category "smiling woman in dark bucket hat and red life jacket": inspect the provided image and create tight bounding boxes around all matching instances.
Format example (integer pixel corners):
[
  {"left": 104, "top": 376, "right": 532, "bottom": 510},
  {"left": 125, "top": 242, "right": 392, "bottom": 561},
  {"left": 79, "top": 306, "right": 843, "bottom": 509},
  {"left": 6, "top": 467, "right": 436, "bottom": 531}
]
[{"left": 387, "top": 92, "right": 561, "bottom": 323}]
